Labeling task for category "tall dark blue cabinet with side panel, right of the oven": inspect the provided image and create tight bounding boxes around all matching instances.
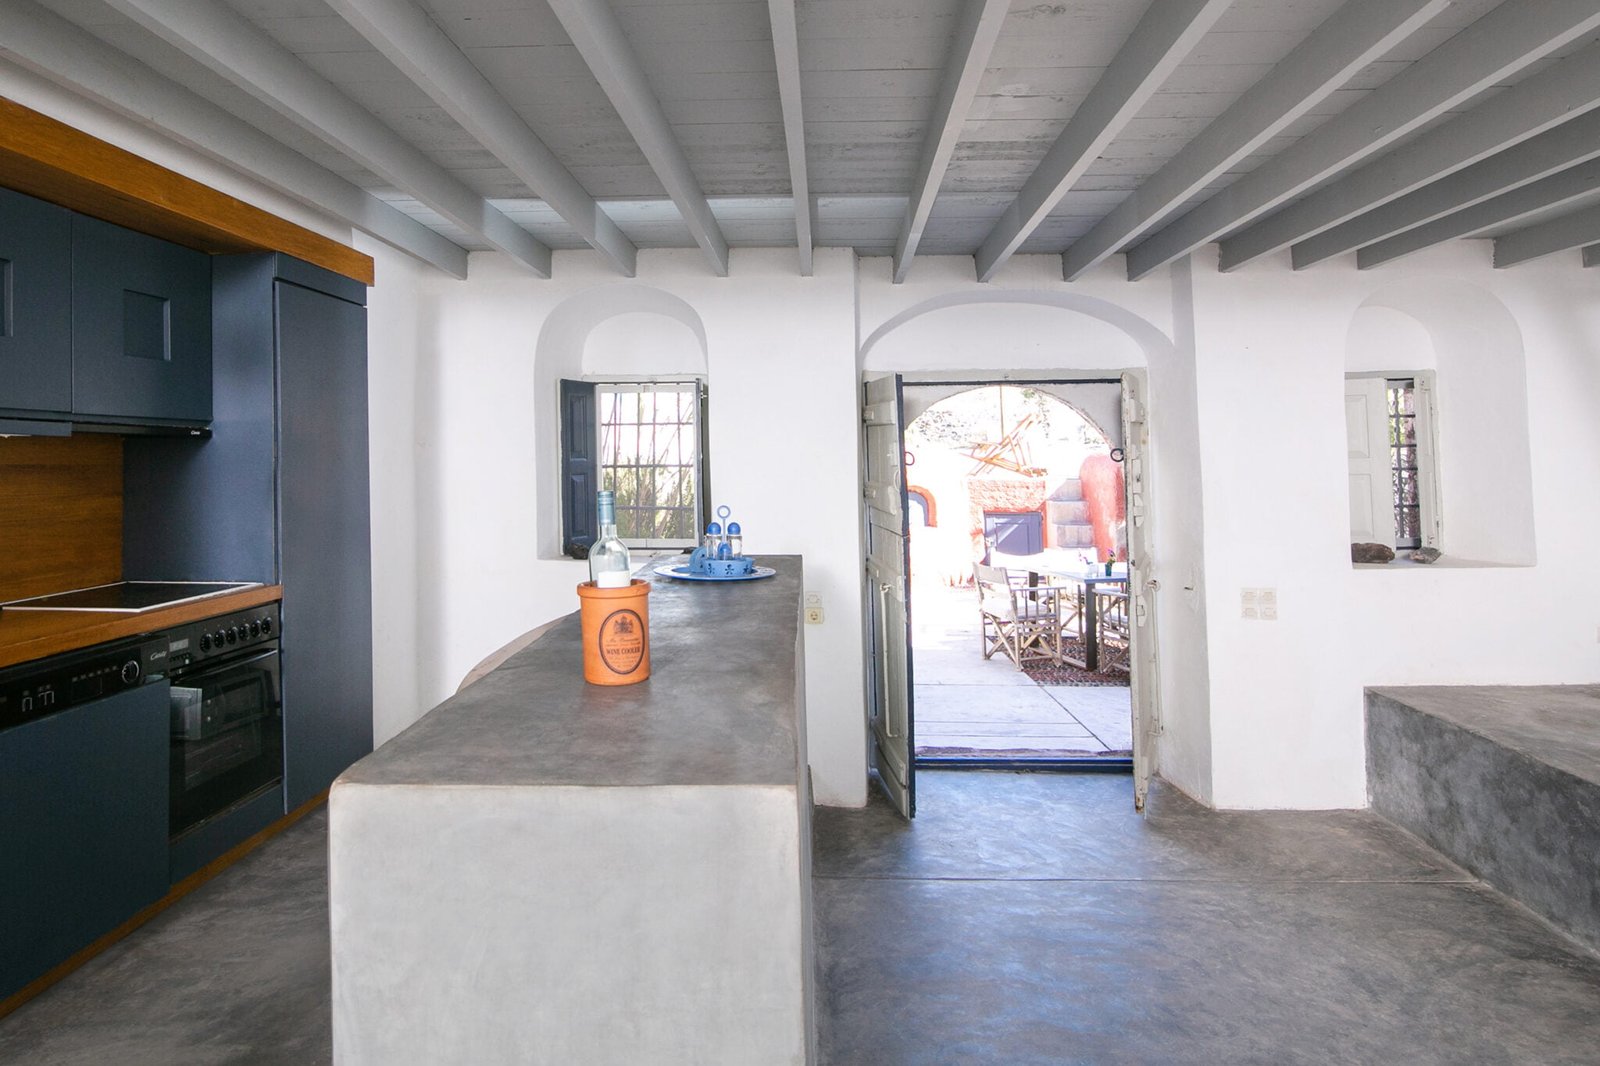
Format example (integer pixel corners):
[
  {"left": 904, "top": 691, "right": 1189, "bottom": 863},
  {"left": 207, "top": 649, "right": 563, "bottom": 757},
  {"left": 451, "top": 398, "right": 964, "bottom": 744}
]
[{"left": 123, "top": 253, "right": 373, "bottom": 810}]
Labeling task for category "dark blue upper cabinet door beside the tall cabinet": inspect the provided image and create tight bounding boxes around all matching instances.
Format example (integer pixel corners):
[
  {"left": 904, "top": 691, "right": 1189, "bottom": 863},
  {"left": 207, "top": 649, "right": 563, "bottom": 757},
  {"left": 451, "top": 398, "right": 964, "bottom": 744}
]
[{"left": 72, "top": 214, "right": 211, "bottom": 426}]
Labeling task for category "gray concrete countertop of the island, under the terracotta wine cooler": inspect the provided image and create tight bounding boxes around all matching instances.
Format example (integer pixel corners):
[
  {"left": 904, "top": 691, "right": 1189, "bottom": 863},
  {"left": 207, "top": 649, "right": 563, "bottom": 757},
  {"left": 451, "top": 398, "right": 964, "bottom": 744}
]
[{"left": 344, "top": 555, "right": 803, "bottom": 787}]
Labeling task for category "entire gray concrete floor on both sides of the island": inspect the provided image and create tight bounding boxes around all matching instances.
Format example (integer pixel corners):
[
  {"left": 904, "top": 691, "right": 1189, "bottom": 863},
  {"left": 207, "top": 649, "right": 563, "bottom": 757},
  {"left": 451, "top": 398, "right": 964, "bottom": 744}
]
[{"left": 0, "top": 771, "right": 1600, "bottom": 1066}]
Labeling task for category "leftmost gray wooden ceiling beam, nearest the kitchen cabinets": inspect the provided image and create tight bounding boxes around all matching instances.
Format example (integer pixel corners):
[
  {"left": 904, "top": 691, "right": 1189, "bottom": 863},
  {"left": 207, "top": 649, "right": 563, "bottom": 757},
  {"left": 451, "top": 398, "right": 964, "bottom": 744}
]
[{"left": 0, "top": 0, "right": 467, "bottom": 279}]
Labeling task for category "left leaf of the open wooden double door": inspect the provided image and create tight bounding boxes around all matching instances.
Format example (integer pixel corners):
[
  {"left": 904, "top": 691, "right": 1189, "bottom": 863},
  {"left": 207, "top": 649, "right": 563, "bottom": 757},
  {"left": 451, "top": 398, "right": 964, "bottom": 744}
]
[{"left": 862, "top": 375, "right": 917, "bottom": 818}]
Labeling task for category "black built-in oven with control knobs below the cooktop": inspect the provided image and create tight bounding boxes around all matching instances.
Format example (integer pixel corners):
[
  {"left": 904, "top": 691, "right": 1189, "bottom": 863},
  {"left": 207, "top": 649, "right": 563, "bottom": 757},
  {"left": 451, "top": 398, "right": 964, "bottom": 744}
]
[{"left": 166, "top": 603, "right": 283, "bottom": 840}]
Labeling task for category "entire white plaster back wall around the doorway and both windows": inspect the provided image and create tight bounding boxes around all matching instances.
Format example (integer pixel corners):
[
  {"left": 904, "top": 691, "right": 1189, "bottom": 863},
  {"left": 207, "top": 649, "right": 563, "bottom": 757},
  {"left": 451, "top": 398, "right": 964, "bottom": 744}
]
[{"left": 363, "top": 236, "right": 1600, "bottom": 808}]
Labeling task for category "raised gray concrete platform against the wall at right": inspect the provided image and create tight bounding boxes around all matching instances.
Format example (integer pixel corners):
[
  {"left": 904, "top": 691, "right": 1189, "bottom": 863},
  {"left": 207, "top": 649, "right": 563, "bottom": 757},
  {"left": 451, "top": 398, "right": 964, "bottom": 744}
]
[{"left": 1366, "top": 685, "right": 1600, "bottom": 951}]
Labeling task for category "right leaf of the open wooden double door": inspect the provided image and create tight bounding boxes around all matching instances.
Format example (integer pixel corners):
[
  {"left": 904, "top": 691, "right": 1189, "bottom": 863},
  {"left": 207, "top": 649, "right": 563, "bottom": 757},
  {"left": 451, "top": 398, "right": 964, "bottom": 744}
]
[{"left": 1122, "top": 370, "right": 1162, "bottom": 812}]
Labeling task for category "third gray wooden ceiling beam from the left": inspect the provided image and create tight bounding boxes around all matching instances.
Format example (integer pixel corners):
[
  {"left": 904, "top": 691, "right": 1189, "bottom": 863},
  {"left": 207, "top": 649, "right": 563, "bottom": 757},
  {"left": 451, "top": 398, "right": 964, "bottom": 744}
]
[{"left": 326, "top": 0, "right": 638, "bottom": 277}]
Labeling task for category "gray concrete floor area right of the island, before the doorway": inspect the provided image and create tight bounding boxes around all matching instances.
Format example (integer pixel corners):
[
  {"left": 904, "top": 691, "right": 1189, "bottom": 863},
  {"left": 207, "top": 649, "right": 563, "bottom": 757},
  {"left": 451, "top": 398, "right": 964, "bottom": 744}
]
[{"left": 814, "top": 771, "right": 1600, "bottom": 1066}]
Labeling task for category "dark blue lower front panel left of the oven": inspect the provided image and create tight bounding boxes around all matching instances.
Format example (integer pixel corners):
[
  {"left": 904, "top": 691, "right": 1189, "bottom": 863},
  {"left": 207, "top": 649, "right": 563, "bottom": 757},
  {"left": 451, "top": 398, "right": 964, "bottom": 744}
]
[{"left": 0, "top": 682, "right": 171, "bottom": 999}]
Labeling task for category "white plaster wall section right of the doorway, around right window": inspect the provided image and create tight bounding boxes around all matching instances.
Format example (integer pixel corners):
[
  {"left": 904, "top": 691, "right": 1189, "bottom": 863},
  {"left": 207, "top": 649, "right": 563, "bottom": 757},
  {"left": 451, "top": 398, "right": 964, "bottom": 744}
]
[{"left": 1194, "top": 243, "right": 1600, "bottom": 807}]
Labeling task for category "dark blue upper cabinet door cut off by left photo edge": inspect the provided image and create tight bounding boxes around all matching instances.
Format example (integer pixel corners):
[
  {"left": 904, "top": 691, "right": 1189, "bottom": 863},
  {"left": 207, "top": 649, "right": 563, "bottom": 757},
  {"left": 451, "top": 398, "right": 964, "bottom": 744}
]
[{"left": 0, "top": 189, "right": 72, "bottom": 416}]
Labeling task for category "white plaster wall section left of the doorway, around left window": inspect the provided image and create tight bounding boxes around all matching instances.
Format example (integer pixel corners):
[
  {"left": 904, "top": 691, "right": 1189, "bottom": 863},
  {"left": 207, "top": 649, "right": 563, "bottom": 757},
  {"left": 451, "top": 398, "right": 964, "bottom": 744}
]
[{"left": 393, "top": 248, "right": 866, "bottom": 805}]
